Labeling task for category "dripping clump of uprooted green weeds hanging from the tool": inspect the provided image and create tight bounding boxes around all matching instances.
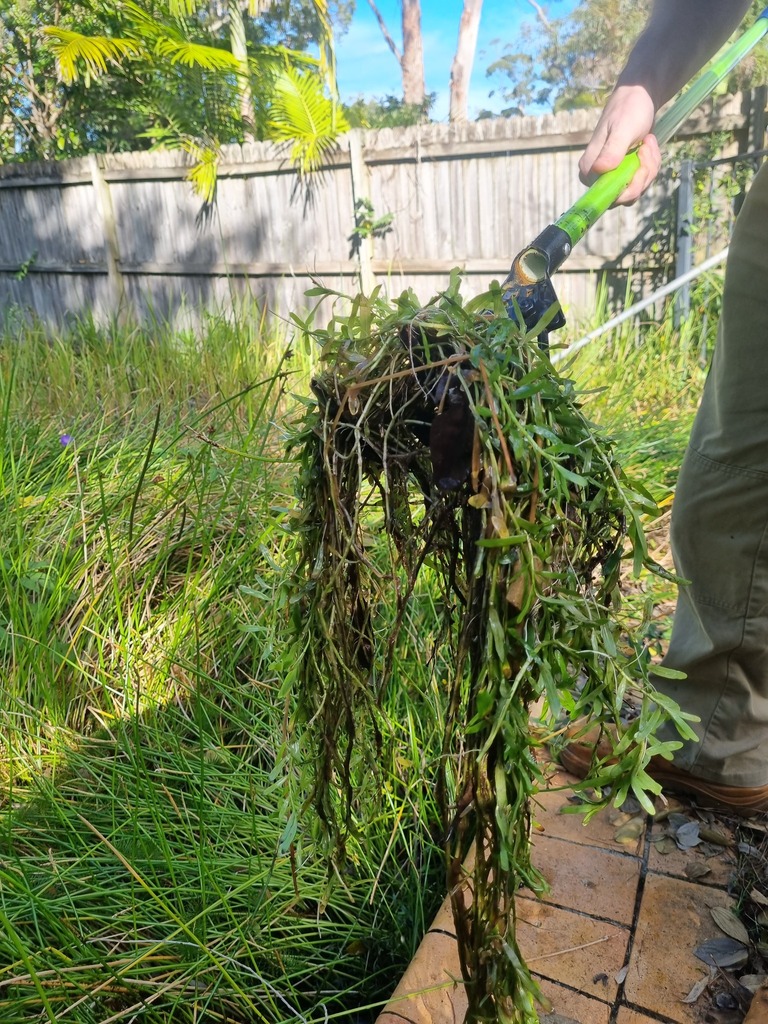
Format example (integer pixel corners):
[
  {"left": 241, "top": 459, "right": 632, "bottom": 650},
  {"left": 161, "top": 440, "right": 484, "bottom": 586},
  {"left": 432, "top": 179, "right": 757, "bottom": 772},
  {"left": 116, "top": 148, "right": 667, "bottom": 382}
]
[{"left": 286, "top": 276, "right": 692, "bottom": 1022}]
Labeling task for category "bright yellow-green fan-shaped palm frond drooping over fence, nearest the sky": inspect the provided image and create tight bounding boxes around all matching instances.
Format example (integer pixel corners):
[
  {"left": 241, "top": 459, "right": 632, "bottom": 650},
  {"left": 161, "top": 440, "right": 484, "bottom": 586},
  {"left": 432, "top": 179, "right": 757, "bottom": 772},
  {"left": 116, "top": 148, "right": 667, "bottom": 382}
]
[{"left": 268, "top": 67, "right": 349, "bottom": 174}]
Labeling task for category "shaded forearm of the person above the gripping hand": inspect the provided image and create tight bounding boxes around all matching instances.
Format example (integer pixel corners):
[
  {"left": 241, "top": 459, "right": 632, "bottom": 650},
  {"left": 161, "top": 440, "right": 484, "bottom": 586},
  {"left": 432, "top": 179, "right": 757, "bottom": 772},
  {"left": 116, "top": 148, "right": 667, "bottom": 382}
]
[{"left": 616, "top": 0, "right": 750, "bottom": 110}]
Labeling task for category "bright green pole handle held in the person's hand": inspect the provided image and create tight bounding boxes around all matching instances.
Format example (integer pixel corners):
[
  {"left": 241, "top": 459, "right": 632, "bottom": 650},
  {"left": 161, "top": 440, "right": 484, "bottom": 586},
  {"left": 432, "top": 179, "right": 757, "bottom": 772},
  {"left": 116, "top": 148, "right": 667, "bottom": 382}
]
[{"left": 555, "top": 8, "right": 768, "bottom": 246}]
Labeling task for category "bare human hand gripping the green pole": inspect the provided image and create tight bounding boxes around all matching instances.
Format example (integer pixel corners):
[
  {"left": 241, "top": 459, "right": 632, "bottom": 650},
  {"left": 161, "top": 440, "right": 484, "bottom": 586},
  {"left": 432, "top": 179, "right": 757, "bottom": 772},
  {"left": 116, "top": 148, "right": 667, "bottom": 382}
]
[{"left": 579, "top": 85, "right": 662, "bottom": 206}]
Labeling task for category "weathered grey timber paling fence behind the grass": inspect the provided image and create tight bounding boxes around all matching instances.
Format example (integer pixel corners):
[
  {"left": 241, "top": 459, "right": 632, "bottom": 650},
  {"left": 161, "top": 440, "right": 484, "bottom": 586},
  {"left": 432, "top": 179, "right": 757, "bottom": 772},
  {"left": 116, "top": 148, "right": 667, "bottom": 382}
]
[{"left": 0, "top": 96, "right": 750, "bottom": 325}]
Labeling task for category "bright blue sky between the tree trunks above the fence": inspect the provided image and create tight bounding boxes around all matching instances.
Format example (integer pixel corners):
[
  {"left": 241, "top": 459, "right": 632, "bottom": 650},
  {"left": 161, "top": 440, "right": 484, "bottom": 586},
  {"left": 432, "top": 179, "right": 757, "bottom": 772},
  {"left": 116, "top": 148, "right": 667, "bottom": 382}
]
[{"left": 336, "top": 0, "right": 577, "bottom": 121}]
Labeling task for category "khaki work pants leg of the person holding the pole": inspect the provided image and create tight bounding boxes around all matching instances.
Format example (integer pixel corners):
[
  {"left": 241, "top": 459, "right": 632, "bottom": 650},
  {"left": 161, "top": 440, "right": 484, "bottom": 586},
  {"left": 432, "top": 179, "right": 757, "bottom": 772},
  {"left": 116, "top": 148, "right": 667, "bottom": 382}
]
[{"left": 653, "top": 164, "right": 768, "bottom": 786}]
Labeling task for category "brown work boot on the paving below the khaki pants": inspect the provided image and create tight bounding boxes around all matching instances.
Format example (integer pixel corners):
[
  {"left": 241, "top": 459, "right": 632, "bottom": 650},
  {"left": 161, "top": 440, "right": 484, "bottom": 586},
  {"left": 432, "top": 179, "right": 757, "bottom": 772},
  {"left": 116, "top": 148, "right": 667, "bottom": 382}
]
[{"left": 557, "top": 727, "right": 768, "bottom": 817}]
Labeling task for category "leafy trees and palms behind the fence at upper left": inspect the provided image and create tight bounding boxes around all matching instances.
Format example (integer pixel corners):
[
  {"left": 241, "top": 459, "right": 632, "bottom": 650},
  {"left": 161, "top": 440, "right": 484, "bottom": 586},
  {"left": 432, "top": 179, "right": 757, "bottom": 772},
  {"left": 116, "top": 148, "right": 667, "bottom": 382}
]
[{"left": 0, "top": 0, "right": 344, "bottom": 184}]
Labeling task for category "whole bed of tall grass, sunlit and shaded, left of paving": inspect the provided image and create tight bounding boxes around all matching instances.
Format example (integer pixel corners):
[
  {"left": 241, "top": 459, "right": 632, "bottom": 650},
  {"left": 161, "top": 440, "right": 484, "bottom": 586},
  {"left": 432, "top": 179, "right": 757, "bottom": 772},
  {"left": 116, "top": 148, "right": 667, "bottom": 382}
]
[{"left": 0, "top": 309, "right": 441, "bottom": 1024}]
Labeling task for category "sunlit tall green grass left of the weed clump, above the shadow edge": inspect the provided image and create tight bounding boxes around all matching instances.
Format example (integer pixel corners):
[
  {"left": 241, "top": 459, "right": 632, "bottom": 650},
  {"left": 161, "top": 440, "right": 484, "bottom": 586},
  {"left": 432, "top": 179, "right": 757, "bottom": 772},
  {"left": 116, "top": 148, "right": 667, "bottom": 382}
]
[{"left": 0, "top": 311, "right": 290, "bottom": 777}]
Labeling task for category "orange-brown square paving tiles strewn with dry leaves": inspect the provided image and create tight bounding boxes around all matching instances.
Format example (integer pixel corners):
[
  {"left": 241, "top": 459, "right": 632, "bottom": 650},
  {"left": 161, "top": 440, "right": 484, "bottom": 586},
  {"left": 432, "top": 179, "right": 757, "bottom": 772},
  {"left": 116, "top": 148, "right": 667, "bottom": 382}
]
[{"left": 377, "top": 768, "right": 768, "bottom": 1024}]
